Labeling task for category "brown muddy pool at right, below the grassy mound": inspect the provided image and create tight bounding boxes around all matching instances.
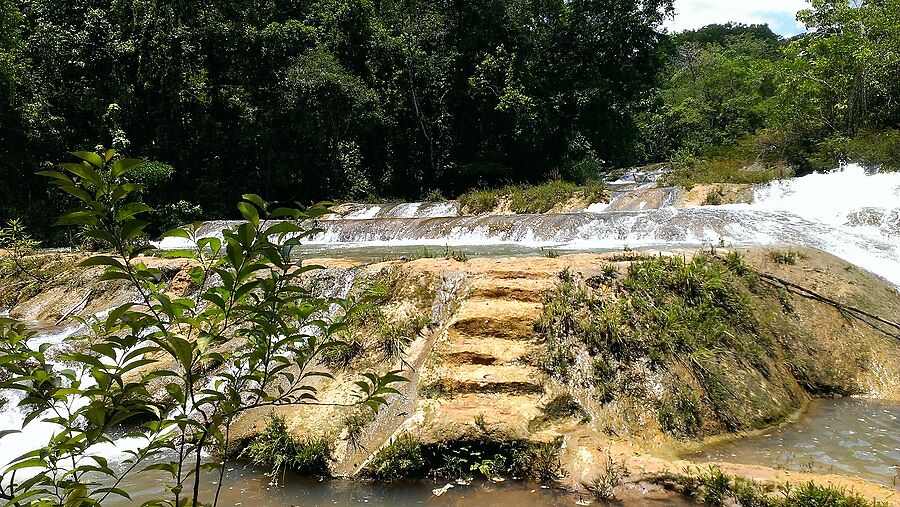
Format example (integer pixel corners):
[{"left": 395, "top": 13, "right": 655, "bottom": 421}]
[{"left": 689, "top": 399, "right": 900, "bottom": 491}]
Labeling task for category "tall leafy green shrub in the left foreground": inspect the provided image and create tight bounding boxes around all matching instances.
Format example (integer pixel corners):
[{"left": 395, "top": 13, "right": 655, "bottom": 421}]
[{"left": 0, "top": 150, "right": 405, "bottom": 506}]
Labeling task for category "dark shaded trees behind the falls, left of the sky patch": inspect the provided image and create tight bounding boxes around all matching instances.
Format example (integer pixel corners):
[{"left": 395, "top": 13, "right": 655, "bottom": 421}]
[{"left": 0, "top": 0, "right": 671, "bottom": 238}]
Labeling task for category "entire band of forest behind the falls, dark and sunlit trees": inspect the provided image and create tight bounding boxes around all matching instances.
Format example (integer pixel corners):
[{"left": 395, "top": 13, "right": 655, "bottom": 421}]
[{"left": 0, "top": 0, "right": 900, "bottom": 240}]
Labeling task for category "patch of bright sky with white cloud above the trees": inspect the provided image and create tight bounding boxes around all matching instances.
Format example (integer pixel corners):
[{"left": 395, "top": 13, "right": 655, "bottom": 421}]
[{"left": 665, "top": 0, "right": 809, "bottom": 36}]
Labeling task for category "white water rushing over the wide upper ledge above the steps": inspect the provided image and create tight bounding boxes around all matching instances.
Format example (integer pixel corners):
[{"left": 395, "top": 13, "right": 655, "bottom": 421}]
[{"left": 158, "top": 165, "right": 900, "bottom": 286}]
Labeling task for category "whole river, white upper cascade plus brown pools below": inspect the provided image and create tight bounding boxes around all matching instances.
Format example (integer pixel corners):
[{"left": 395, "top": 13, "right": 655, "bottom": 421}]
[{"left": 7, "top": 165, "right": 900, "bottom": 506}]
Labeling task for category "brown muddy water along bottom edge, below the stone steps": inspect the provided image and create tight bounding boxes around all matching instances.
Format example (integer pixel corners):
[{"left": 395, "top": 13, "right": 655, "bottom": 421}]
[{"left": 112, "top": 465, "right": 694, "bottom": 507}]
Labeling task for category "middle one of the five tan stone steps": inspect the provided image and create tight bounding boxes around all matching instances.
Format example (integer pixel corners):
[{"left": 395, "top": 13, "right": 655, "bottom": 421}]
[{"left": 438, "top": 329, "right": 541, "bottom": 365}]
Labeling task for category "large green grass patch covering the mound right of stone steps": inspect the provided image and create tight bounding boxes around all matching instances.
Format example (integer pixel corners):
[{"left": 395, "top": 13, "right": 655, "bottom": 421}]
[{"left": 538, "top": 253, "right": 785, "bottom": 438}]
